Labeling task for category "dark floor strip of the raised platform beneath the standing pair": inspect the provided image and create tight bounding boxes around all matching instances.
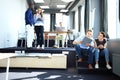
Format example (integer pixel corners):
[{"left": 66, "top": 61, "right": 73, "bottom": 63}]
[{"left": 0, "top": 47, "right": 75, "bottom": 53}]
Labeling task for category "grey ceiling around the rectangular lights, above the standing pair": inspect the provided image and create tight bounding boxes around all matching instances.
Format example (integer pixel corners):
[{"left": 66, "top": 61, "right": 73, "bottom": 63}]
[{"left": 27, "top": 0, "right": 85, "bottom": 13}]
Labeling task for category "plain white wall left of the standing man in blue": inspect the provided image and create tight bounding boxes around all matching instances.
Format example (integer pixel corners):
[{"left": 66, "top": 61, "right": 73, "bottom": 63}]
[{"left": 0, "top": 0, "right": 28, "bottom": 48}]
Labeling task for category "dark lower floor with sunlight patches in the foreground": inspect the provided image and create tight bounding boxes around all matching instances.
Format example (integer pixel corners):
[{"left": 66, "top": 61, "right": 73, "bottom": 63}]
[{"left": 0, "top": 68, "right": 120, "bottom": 80}]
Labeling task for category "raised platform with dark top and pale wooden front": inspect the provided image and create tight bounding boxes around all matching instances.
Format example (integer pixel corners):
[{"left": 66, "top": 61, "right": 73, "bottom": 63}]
[{"left": 0, "top": 47, "right": 75, "bottom": 69}]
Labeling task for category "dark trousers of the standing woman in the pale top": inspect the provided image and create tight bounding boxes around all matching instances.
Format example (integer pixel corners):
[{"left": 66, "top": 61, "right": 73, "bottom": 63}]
[{"left": 35, "top": 26, "right": 44, "bottom": 46}]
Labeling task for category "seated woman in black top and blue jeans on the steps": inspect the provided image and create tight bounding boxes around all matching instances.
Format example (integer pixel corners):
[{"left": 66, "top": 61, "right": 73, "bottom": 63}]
[{"left": 95, "top": 32, "right": 111, "bottom": 69}]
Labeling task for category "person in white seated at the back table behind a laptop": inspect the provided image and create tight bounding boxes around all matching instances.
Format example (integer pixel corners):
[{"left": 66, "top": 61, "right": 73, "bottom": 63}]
[{"left": 54, "top": 22, "right": 65, "bottom": 48}]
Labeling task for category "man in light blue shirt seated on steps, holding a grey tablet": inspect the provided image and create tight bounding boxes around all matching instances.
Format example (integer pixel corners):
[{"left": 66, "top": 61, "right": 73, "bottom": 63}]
[{"left": 73, "top": 30, "right": 94, "bottom": 69}]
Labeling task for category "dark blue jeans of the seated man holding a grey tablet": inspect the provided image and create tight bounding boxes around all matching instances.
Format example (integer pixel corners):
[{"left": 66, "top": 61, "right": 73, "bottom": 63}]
[{"left": 75, "top": 44, "right": 94, "bottom": 64}]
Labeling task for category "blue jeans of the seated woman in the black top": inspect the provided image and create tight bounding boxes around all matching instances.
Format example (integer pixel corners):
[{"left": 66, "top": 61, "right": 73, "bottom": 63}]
[{"left": 95, "top": 48, "right": 109, "bottom": 62}]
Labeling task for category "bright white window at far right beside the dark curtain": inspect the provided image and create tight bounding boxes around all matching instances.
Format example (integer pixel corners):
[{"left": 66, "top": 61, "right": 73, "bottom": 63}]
[{"left": 108, "top": 0, "right": 117, "bottom": 39}]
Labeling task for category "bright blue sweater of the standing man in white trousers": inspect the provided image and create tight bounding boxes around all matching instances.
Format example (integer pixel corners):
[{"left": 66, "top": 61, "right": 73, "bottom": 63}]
[{"left": 25, "top": 9, "right": 34, "bottom": 25}]
